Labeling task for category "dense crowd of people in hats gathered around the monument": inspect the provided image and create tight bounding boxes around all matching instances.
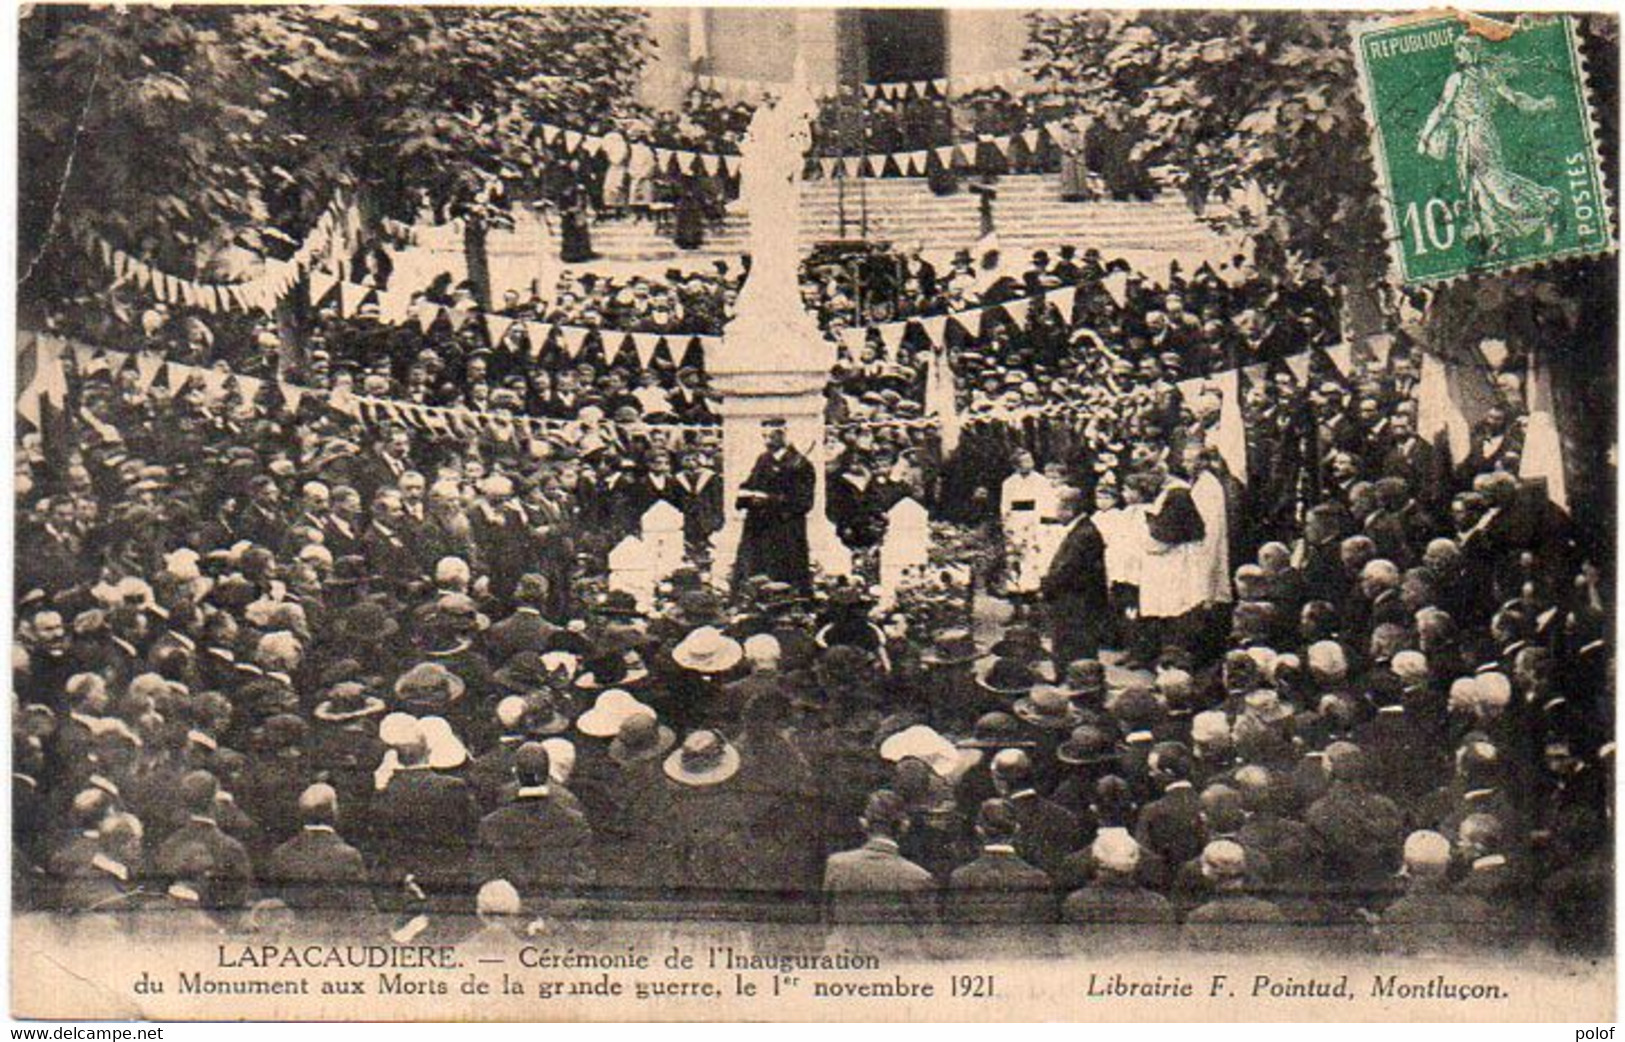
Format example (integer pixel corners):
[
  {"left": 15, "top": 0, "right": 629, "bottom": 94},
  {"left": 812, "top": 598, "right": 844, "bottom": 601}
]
[{"left": 13, "top": 158, "right": 1614, "bottom": 953}]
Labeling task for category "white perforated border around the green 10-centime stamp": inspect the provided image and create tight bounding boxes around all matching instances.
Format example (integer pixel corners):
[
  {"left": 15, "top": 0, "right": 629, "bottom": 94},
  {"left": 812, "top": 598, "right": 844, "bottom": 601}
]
[{"left": 1349, "top": 11, "right": 1619, "bottom": 286}]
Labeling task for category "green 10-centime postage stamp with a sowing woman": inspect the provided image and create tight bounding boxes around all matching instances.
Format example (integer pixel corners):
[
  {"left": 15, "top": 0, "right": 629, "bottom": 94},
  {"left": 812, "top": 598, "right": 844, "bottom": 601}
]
[{"left": 1354, "top": 15, "right": 1614, "bottom": 283}]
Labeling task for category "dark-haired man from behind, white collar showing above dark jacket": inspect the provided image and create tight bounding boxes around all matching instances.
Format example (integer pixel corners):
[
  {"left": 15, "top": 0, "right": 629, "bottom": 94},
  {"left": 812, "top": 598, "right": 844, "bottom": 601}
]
[{"left": 478, "top": 741, "right": 593, "bottom": 901}]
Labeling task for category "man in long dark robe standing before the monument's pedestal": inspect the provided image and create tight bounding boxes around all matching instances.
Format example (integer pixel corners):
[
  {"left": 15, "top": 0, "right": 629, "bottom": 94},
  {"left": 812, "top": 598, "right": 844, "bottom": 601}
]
[{"left": 735, "top": 419, "right": 817, "bottom": 592}]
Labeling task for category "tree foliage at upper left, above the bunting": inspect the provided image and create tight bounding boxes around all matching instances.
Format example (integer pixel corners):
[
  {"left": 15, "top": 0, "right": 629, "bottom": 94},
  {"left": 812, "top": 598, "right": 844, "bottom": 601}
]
[{"left": 20, "top": 5, "right": 648, "bottom": 295}]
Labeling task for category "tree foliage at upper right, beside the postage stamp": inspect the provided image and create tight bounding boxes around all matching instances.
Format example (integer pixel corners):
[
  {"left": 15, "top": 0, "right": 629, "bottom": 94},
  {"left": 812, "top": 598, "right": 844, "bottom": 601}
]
[{"left": 1027, "top": 11, "right": 1383, "bottom": 278}]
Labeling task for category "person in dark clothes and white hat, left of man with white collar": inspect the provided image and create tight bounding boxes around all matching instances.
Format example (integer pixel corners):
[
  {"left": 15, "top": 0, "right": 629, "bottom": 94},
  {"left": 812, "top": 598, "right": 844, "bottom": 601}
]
[{"left": 369, "top": 722, "right": 479, "bottom": 896}]
